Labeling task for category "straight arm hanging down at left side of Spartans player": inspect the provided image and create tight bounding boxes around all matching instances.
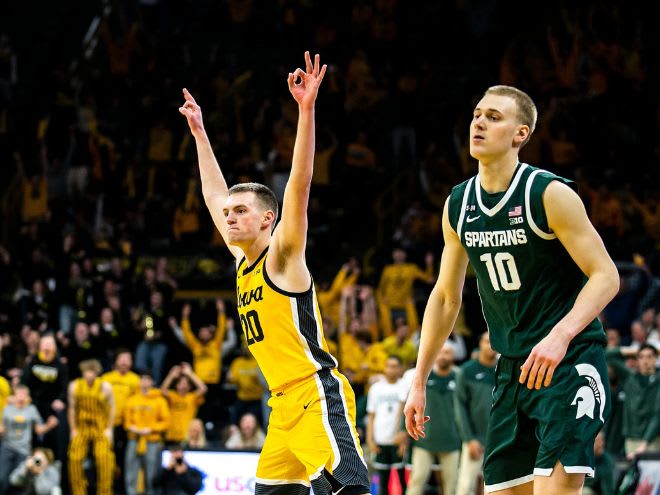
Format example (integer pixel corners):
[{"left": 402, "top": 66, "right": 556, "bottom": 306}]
[{"left": 403, "top": 200, "right": 468, "bottom": 440}]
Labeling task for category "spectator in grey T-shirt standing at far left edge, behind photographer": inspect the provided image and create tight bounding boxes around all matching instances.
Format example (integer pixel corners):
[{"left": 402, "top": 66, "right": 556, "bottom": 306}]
[{"left": 0, "top": 385, "right": 57, "bottom": 493}]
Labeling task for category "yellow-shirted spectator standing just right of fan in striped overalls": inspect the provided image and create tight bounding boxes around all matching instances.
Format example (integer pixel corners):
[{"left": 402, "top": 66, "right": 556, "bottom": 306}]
[{"left": 101, "top": 349, "right": 140, "bottom": 486}]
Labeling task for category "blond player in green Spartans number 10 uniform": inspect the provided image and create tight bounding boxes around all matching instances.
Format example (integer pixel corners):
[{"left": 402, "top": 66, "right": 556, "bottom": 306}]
[{"left": 404, "top": 86, "right": 619, "bottom": 495}]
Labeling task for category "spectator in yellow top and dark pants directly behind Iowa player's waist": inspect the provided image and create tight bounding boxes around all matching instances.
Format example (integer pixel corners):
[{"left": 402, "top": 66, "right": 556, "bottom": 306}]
[{"left": 227, "top": 341, "right": 264, "bottom": 425}]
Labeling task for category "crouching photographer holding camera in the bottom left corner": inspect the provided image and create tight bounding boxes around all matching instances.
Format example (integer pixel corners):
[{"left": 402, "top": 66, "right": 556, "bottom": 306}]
[{"left": 9, "top": 447, "right": 60, "bottom": 495}]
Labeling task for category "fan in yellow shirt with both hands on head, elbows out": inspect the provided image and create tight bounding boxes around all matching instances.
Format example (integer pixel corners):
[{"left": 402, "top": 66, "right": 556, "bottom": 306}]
[{"left": 160, "top": 363, "right": 206, "bottom": 442}]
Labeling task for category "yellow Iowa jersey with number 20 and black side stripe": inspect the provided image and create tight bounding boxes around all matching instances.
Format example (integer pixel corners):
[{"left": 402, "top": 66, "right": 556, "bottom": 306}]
[{"left": 236, "top": 249, "right": 337, "bottom": 390}]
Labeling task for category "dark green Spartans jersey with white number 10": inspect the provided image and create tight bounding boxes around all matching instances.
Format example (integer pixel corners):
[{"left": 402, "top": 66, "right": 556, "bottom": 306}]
[{"left": 448, "top": 163, "right": 606, "bottom": 358}]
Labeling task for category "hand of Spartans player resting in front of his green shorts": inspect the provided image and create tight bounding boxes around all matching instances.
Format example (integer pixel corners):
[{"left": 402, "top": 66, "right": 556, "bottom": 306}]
[{"left": 519, "top": 329, "right": 570, "bottom": 390}]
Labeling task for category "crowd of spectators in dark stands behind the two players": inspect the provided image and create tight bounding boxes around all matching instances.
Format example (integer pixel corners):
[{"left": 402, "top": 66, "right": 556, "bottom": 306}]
[{"left": 0, "top": 0, "right": 660, "bottom": 494}]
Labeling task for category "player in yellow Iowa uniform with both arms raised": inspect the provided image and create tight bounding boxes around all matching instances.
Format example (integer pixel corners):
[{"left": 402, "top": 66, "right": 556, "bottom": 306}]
[{"left": 179, "top": 52, "right": 369, "bottom": 495}]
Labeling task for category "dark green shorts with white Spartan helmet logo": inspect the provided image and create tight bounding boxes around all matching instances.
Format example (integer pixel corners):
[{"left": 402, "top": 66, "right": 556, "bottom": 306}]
[{"left": 484, "top": 342, "right": 610, "bottom": 492}]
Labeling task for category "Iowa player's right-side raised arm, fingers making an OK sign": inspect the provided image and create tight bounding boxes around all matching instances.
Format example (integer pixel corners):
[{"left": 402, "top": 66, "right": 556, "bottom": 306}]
[{"left": 269, "top": 52, "right": 326, "bottom": 272}]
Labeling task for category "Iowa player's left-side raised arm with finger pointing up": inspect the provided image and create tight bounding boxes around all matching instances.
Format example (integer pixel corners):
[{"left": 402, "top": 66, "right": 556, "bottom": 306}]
[{"left": 179, "top": 88, "right": 243, "bottom": 258}]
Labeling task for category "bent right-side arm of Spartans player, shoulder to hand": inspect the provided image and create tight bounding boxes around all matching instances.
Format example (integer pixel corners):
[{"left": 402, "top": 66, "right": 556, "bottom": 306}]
[{"left": 520, "top": 181, "right": 619, "bottom": 389}]
